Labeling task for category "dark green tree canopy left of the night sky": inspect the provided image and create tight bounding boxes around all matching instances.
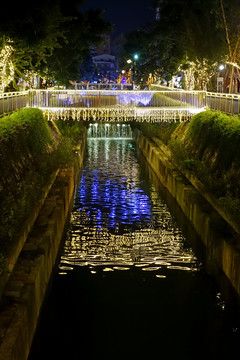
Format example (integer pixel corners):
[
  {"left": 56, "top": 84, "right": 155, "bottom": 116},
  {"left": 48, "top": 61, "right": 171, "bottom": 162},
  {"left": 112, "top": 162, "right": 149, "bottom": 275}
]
[{"left": 0, "top": 0, "right": 111, "bottom": 89}]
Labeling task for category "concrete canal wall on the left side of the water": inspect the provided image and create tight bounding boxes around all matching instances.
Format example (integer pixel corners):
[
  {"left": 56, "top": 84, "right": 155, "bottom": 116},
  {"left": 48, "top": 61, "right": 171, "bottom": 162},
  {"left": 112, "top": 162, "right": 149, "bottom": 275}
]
[{"left": 0, "top": 138, "right": 86, "bottom": 360}]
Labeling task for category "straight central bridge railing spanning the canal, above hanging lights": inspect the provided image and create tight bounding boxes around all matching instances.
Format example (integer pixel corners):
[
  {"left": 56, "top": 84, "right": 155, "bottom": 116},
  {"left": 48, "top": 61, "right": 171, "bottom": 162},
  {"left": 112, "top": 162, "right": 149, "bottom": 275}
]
[{"left": 29, "top": 90, "right": 205, "bottom": 108}]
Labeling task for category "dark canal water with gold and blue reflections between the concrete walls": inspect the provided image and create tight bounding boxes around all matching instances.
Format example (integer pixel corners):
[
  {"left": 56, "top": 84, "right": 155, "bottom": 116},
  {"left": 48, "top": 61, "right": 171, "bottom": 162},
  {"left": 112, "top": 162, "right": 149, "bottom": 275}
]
[{"left": 29, "top": 134, "right": 239, "bottom": 360}]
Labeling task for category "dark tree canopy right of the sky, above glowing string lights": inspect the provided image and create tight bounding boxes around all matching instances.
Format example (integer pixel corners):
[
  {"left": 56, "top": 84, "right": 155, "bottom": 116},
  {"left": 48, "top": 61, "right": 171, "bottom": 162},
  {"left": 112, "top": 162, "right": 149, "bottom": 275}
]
[{"left": 125, "top": 0, "right": 233, "bottom": 88}]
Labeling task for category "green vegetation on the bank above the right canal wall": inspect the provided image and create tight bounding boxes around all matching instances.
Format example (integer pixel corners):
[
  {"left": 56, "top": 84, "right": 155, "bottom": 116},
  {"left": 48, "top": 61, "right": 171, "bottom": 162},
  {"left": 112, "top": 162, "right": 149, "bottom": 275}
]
[{"left": 134, "top": 110, "right": 240, "bottom": 225}]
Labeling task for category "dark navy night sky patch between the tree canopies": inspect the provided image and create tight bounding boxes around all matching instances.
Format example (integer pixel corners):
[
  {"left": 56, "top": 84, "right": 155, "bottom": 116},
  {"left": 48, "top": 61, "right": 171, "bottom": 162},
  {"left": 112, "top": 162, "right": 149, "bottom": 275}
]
[{"left": 80, "top": 0, "right": 155, "bottom": 37}]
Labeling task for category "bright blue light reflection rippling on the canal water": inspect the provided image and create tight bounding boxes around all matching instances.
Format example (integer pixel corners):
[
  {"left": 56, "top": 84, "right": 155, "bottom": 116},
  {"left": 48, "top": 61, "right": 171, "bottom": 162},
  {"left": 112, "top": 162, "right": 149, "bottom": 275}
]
[{"left": 77, "top": 170, "right": 152, "bottom": 232}]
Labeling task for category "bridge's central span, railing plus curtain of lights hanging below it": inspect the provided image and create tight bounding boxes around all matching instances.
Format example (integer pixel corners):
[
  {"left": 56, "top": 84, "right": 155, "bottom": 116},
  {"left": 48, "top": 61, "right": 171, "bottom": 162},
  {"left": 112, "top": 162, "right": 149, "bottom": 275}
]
[{"left": 30, "top": 90, "right": 205, "bottom": 122}]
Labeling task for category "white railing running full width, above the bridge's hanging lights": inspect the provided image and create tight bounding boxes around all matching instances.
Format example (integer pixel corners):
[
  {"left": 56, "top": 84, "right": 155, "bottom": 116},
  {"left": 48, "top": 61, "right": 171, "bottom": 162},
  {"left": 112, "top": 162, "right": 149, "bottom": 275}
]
[{"left": 0, "top": 88, "right": 240, "bottom": 115}]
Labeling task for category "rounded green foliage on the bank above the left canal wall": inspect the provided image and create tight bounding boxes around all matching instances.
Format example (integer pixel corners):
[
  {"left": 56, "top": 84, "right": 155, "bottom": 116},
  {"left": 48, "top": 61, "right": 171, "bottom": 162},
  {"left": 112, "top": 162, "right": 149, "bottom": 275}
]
[{"left": 0, "top": 108, "right": 53, "bottom": 249}]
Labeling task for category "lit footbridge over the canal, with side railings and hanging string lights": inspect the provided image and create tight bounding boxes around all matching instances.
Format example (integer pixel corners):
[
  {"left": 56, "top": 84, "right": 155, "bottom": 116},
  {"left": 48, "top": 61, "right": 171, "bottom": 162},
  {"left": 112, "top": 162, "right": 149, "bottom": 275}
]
[{"left": 0, "top": 89, "right": 240, "bottom": 122}]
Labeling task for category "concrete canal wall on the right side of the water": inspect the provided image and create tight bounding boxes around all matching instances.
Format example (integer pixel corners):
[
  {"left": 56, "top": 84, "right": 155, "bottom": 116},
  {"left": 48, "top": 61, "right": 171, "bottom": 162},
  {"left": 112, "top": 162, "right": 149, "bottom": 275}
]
[{"left": 135, "top": 131, "right": 240, "bottom": 308}]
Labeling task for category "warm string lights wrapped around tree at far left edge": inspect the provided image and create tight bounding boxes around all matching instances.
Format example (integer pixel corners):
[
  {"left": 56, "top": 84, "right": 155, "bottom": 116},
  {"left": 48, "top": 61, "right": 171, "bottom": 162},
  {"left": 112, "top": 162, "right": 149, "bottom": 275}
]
[{"left": 0, "top": 40, "right": 15, "bottom": 92}]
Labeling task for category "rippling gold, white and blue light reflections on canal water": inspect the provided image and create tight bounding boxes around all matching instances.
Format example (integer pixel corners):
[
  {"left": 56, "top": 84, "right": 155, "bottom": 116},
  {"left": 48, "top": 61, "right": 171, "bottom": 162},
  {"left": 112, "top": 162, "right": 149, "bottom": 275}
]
[{"left": 59, "top": 139, "right": 197, "bottom": 278}]
